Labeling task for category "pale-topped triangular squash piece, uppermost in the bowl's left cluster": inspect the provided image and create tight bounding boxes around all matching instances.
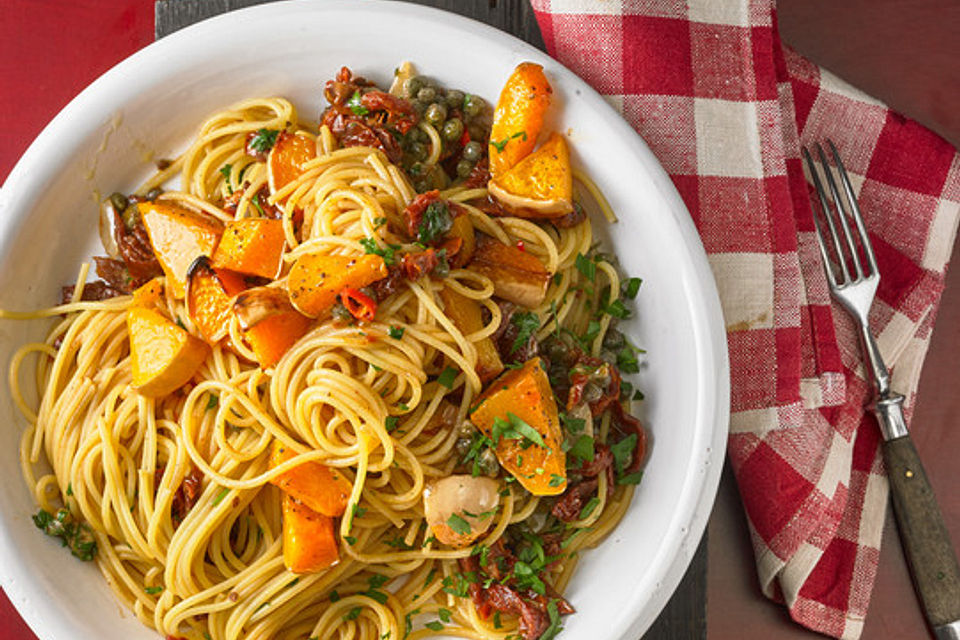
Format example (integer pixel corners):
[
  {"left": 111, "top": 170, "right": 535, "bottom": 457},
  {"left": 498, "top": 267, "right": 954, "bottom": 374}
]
[{"left": 137, "top": 200, "right": 223, "bottom": 298}]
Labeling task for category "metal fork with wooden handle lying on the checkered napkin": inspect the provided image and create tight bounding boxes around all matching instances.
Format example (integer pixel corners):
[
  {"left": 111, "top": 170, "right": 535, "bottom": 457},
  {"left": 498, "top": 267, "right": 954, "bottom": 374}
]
[{"left": 803, "top": 140, "right": 960, "bottom": 640}]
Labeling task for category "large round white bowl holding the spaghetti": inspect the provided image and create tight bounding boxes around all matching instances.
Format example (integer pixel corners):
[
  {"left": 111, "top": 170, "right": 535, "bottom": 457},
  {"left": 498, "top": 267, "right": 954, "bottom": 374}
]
[{"left": 0, "top": 1, "right": 729, "bottom": 640}]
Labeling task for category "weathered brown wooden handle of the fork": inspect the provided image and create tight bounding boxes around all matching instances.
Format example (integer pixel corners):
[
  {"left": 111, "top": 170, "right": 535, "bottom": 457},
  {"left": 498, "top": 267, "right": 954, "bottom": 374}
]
[{"left": 878, "top": 422, "right": 960, "bottom": 628}]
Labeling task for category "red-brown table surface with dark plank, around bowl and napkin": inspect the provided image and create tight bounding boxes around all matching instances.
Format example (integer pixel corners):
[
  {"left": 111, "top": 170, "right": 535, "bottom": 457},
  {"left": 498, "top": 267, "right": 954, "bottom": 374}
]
[{"left": 0, "top": 0, "right": 960, "bottom": 640}]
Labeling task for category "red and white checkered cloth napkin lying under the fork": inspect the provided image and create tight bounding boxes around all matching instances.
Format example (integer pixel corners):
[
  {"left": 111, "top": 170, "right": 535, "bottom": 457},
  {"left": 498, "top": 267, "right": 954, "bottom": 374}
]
[{"left": 532, "top": 0, "right": 960, "bottom": 638}]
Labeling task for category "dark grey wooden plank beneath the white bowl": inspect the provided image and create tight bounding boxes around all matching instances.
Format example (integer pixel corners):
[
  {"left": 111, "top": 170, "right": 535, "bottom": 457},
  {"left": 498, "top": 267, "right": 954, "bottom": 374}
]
[{"left": 156, "top": 0, "right": 707, "bottom": 640}]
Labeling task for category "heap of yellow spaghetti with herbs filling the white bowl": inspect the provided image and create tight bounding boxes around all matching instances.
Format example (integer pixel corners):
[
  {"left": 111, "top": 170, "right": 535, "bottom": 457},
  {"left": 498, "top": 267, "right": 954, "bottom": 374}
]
[{"left": 0, "top": 62, "right": 643, "bottom": 640}]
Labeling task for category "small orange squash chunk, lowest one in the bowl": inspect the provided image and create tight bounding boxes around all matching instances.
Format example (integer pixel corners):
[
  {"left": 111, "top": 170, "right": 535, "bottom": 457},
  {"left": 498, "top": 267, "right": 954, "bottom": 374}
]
[{"left": 283, "top": 494, "right": 340, "bottom": 573}]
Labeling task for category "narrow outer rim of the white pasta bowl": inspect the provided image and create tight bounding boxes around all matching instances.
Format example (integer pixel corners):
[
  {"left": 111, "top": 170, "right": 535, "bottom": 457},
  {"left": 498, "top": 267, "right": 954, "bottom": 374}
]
[{"left": 0, "top": 0, "right": 730, "bottom": 640}]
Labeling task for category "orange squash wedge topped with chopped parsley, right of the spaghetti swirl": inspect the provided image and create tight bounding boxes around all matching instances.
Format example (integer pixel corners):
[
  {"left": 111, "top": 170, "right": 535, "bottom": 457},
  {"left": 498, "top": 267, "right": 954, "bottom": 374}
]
[{"left": 470, "top": 358, "right": 567, "bottom": 496}]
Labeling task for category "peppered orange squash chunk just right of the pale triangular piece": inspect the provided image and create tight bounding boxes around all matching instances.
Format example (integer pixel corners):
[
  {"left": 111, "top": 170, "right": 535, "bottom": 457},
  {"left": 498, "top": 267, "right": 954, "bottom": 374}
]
[{"left": 211, "top": 218, "right": 287, "bottom": 279}]
